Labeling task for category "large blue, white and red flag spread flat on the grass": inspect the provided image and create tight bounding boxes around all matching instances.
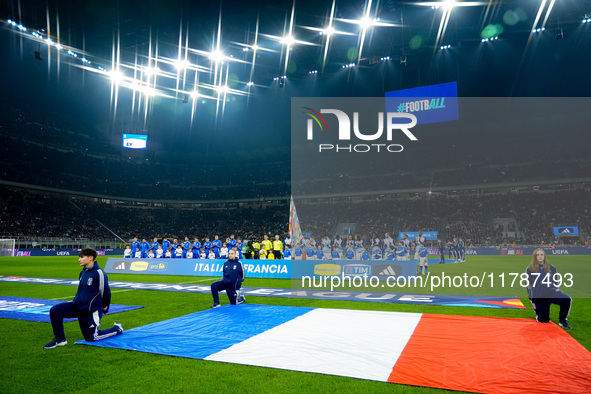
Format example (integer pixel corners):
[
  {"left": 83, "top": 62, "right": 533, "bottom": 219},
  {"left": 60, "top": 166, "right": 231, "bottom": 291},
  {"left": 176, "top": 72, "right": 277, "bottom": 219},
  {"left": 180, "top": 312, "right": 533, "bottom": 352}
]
[{"left": 79, "top": 305, "right": 591, "bottom": 393}]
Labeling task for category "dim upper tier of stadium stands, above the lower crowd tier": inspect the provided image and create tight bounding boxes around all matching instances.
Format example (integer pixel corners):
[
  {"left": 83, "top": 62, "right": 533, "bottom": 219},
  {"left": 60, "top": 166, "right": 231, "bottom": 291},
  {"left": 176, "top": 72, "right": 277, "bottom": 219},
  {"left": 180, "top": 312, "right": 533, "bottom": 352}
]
[{"left": 0, "top": 108, "right": 591, "bottom": 201}]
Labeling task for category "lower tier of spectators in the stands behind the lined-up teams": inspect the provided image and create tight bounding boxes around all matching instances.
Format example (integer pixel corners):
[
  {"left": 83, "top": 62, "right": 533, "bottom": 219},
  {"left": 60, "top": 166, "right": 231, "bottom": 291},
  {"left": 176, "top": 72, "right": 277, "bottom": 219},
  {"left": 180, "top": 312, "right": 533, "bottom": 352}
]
[{"left": 0, "top": 185, "right": 591, "bottom": 246}]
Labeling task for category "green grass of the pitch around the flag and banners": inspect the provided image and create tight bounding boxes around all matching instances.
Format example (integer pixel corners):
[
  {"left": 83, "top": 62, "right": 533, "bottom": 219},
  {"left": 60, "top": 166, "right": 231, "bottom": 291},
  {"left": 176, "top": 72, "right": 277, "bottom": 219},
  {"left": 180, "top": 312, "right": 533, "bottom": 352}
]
[{"left": 0, "top": 256, "right": 591, "bottom": 393}]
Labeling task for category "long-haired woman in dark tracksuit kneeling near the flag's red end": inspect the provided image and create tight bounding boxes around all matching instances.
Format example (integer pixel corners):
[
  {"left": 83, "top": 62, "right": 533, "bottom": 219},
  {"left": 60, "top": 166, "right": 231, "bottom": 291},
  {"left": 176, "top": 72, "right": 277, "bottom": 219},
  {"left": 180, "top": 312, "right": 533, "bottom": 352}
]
[{"left": 525, "top": 248, "right": 572, "bottom": 328}]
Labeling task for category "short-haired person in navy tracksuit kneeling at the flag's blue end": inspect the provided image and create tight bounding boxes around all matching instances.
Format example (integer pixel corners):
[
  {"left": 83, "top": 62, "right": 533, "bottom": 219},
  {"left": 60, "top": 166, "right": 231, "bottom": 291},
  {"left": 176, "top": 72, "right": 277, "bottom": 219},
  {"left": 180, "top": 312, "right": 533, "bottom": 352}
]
[{"left": 43, "top": 248, "right": 123, "bottom": 349}]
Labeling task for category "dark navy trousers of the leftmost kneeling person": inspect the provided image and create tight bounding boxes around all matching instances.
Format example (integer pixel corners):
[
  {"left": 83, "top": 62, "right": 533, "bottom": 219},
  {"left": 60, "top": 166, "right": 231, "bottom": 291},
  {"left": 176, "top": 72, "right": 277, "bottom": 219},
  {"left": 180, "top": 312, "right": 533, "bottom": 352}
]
[{"left": 49, "top": 302, "right": 117, "bottom": 342}]
